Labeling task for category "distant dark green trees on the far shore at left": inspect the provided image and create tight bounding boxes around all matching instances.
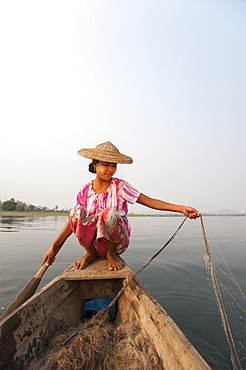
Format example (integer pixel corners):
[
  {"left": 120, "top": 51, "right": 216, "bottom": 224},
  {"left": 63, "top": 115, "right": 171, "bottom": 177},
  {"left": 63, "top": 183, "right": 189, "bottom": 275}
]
[{"left": 0, "top": 198, "right": 66, "bottom": 212}]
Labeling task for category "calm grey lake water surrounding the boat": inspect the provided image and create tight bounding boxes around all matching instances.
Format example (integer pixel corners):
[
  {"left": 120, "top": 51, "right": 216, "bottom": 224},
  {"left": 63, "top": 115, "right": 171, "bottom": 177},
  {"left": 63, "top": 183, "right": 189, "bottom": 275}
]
[{"left": 0, "top": 215, "right": 246, "bottom": 370}]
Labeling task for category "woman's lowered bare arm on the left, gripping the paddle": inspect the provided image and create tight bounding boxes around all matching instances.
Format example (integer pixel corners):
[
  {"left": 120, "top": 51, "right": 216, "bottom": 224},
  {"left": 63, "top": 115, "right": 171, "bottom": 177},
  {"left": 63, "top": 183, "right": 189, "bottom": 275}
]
[{"left": 41, "top": 221, "right": 72, "bottom": 266}]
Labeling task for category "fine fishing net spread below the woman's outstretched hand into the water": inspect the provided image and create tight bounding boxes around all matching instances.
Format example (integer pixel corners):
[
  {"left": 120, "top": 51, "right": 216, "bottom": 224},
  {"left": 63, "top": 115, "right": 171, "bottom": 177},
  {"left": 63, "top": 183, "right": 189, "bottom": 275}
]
[{"left": 173, "top": 216, "right": 246, "bottom": 370}]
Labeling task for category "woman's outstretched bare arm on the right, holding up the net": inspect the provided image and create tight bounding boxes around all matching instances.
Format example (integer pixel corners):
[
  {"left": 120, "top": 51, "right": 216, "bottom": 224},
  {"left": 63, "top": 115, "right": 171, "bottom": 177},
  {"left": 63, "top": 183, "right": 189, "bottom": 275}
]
[{"left": 137, "top": 193, "right": 201, "bottom": 219}]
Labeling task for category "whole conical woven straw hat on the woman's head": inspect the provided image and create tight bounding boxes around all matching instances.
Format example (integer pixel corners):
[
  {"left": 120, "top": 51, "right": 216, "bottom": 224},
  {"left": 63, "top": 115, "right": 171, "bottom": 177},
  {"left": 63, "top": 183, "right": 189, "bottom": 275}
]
[{"left": 78, "top": 141, "right": 133, "bottom": 163}]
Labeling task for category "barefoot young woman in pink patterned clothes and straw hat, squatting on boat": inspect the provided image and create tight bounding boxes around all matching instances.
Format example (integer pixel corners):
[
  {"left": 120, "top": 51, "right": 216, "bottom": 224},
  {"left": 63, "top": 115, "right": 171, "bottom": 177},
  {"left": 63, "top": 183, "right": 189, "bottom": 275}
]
[{"left": 41, "top": 141, "right": 200, "bottom": 270}]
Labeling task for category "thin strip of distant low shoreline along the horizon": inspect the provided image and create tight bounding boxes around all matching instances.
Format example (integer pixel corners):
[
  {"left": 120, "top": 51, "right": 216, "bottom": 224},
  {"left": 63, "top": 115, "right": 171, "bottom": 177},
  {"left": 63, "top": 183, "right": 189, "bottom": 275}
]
[{"left": 0, "top": 211, "right": 246, "bottom": 217}]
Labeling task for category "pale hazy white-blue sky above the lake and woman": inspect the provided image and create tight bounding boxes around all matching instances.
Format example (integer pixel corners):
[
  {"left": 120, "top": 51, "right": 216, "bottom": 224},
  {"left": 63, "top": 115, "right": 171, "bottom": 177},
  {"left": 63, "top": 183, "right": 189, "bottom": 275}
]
[{"left": 0, "top": 0, "right": 246, "bottom": 213}]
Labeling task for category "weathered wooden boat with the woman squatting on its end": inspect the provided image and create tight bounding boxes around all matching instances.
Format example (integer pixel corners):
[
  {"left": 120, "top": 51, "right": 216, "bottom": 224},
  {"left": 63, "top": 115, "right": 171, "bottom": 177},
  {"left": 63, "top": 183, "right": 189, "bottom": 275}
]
[{"left": 0, "top": 259, "right": 210, "bottom": 370}]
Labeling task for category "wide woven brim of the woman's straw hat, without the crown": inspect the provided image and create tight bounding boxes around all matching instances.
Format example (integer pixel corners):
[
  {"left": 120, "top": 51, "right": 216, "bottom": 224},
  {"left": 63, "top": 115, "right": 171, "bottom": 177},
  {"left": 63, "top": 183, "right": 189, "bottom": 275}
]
[{"left": 78, "top": 149, "right": 133, "bottom": 164}]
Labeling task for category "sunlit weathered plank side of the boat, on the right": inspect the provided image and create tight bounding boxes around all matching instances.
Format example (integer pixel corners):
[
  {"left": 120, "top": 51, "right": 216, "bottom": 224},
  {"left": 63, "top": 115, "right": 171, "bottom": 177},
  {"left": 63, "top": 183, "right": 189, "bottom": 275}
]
[{"left": 119, "top": 279, "right": 210, "bottom": 370}]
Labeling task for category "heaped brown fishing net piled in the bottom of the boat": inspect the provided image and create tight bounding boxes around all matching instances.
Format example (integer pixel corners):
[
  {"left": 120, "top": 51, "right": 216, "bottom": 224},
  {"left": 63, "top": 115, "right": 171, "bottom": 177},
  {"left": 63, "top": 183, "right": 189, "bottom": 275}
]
[{"left": 29, "top": 312, "right": 163, "bottom": 370}]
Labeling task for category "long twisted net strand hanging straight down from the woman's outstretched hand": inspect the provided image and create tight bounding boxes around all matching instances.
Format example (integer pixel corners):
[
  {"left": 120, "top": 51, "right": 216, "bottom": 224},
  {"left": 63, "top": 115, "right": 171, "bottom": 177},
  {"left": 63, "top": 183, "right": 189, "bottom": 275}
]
[{"left": 201, "top": 216, "right": 242, "bottom": 370}]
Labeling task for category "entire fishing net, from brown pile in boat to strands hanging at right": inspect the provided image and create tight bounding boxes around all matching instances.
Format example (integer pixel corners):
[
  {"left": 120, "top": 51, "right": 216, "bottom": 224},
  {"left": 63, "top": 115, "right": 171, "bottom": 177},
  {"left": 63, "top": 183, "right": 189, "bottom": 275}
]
[{"left": 25, "top": 218, "right": 245, "bottom": 370}]
